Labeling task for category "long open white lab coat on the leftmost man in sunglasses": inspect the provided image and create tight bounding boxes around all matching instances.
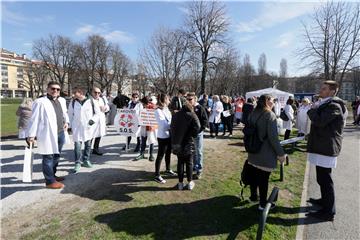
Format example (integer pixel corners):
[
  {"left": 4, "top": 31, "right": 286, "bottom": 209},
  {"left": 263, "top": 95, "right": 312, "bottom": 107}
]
[{"left": 26, "top": 96, "right": 69, "bottom": 155}]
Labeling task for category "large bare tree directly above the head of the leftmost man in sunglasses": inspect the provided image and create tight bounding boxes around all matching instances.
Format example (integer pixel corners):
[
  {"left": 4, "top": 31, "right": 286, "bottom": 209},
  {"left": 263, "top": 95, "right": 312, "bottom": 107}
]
[{"left": 33, "top": 35, "right": 74, "bottom": 94}]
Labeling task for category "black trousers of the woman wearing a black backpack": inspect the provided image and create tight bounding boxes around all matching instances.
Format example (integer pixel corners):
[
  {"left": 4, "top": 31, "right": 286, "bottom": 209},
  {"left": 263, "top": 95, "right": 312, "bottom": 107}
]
[{"left": 250, "top": 165, "right": 270, "bottom": 207}]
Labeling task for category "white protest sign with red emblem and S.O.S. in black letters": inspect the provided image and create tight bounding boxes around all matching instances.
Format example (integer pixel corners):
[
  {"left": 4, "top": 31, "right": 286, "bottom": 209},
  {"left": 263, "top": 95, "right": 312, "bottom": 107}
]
[{"left": 114, "top": 109, "right": 139, "bottom": 136}]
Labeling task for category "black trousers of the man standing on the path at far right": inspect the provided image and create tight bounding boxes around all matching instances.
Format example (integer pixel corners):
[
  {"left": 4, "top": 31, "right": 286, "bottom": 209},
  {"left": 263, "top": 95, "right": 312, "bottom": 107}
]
[{"left": 316, "top": 166, "right": 336, "bottom": 215}]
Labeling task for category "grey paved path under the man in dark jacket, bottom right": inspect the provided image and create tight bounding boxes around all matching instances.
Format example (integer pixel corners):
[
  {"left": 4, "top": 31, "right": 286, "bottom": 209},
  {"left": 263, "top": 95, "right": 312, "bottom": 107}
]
[{"left": 304, "top": 126, "right": 360, "bottom": 240}]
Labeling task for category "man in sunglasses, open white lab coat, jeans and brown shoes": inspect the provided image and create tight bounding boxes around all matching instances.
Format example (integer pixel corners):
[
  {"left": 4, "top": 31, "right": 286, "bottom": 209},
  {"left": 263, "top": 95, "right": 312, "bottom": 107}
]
[{"left": 27, "top": 81, "right": 69, "bottom": 189}]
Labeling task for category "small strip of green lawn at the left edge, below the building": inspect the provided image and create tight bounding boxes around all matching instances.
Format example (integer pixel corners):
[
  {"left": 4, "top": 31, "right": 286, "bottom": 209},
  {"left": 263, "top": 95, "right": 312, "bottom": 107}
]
[{"left": 0, "top": 103, "right": 19, "bottom": 136}]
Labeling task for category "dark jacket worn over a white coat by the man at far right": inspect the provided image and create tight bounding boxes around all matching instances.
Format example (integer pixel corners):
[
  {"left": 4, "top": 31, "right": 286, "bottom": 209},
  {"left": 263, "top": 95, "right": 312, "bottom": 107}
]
[{"left": 307, "top": 97, "right": 346, "bottom": 157}]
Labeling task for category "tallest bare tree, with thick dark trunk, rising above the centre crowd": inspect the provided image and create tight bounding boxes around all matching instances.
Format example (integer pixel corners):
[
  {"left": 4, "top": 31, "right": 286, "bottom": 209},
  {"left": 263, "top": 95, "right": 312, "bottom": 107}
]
[{"left": 185, "top": 0, "right": 229, "bottom": 93}]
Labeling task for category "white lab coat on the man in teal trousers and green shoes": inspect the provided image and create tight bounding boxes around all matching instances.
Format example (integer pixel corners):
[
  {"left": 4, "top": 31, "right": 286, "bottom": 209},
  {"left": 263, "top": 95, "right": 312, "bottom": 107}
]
[{"left": 69, "top": 99, "right": 100, "bottom": 142}]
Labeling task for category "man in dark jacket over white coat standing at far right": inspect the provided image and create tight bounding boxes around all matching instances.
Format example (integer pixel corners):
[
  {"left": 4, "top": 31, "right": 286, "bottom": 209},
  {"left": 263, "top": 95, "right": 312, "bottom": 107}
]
[{"left": 307, "top": 80, "right": 347, "bottom": 221}]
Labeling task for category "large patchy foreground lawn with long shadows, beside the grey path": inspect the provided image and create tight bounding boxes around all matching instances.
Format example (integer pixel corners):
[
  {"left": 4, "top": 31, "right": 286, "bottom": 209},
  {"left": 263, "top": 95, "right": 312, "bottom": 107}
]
[{"left": 19, "top": 128, "right": 306, "bottom": 240}]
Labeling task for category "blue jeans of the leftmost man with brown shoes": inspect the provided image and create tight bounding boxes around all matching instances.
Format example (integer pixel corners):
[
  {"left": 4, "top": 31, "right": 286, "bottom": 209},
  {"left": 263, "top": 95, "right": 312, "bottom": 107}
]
[{"left": 42, "top": 131, "right": 65, "bottom": 185}]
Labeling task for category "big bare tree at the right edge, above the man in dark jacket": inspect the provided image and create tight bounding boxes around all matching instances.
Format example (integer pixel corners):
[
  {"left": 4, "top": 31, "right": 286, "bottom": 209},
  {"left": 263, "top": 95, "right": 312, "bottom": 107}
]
[{"left": 300, "top": 1, "right": 360, "bottom": 91}]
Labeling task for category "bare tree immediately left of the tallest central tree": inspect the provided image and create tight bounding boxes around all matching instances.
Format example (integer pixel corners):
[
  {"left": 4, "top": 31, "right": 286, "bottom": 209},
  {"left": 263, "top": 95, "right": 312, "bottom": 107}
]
[{"left": 141, "top": 28, "right": 188, "bottom": 95}]
